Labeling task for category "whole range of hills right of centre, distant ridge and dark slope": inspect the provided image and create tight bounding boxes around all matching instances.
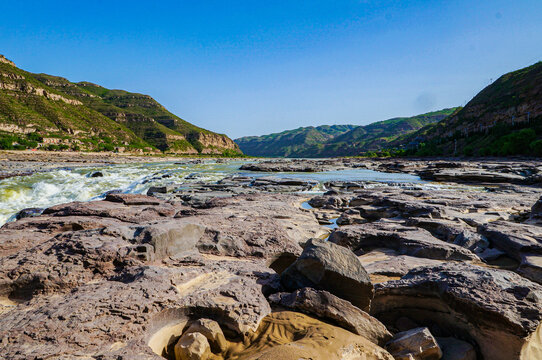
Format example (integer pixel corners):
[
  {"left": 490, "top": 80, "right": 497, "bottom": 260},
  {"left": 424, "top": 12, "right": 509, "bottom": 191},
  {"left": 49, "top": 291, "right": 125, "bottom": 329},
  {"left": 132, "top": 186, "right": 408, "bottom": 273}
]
[{"left": 235, "top": 62, "right": 542, "bottom": 158}]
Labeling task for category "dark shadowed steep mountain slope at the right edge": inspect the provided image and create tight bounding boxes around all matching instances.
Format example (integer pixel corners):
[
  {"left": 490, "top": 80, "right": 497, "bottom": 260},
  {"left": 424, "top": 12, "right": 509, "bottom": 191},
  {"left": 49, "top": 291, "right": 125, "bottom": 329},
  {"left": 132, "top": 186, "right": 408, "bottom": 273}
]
[{"left": 396, "top": 62, "right": 542, "bottom": 156}]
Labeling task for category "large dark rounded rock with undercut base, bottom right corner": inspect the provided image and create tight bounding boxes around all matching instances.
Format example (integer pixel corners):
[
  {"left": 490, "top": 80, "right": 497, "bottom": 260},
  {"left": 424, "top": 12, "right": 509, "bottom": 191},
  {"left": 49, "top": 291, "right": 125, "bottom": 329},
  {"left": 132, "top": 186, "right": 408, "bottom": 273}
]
[{"left": 371, "top": 262, "right": 542, "bottom": 360}]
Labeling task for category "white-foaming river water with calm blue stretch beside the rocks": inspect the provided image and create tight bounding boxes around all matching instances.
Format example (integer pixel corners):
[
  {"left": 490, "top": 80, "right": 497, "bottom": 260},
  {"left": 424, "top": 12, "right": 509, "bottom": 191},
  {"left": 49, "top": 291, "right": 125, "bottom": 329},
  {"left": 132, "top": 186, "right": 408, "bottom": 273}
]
[{"left": 0, "top": 161, "right": 424, "bottom": 226}]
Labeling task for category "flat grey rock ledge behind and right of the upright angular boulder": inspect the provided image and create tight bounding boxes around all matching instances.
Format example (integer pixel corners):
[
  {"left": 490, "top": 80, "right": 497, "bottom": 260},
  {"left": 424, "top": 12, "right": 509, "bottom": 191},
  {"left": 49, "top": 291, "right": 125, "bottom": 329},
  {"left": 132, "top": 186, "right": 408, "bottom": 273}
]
[{"left": 329, "top": 222, "right": 478, "bottom": 260}]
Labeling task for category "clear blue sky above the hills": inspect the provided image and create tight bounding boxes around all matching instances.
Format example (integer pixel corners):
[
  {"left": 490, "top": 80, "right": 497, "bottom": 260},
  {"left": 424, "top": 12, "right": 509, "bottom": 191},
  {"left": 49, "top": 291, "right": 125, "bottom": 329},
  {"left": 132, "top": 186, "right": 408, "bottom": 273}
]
[{"left": 0, "top": 0, "right": 542, "bottom": 138}]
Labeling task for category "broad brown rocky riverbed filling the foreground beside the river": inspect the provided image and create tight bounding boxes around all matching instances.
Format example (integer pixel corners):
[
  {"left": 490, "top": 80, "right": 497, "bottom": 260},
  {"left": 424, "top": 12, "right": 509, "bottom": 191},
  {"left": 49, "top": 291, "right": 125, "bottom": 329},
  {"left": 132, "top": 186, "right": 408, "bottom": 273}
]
[{"left": 0, "top": 159, "right": 542, "bottom": 360}]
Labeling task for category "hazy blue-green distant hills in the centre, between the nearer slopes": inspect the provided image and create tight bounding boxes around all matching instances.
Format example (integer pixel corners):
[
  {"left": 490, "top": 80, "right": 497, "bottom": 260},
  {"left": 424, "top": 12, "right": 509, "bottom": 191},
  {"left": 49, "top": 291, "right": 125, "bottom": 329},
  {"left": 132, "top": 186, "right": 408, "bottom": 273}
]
[{"left": 235, "top": 108, "right": 456, "bottom": 157}]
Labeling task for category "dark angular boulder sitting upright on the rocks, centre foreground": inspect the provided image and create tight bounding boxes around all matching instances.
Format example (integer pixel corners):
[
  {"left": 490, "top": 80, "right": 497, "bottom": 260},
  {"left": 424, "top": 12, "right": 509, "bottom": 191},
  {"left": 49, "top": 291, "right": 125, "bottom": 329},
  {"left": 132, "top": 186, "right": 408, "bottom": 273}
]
[{"left": 281, "top": 239, "right": 373, "bottom": 311}]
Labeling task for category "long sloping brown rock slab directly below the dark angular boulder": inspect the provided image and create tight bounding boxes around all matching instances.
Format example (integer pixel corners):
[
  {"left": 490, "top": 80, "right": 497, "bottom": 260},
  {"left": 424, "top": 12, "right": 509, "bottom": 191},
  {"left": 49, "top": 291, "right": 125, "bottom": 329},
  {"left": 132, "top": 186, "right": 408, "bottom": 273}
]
[{"left": 269, "top": 288, "right": 391, "bottom": 346}]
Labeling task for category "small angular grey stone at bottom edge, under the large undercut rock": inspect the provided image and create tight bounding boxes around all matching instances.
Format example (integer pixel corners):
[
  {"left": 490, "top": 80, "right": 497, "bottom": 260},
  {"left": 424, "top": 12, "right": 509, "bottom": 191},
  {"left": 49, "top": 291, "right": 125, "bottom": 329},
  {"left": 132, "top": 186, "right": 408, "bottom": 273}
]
[{"left": 386, "top": 327, "right": 442, "bottom": 360}]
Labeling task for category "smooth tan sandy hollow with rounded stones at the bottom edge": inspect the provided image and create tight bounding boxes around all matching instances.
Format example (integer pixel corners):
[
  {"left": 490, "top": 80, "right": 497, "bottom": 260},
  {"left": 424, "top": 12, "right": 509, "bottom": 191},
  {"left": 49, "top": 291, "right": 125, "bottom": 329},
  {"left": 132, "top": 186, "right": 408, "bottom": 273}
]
[{"left": 148, "top": 311, "right": 393, "bottom": 360}]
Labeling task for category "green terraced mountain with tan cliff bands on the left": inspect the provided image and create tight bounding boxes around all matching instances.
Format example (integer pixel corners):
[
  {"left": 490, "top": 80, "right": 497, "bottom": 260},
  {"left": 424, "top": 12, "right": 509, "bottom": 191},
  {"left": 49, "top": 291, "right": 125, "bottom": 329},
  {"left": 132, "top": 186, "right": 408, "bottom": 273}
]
[{"left": 0, "top": 55, "right": 240, "bottom": 154}]
